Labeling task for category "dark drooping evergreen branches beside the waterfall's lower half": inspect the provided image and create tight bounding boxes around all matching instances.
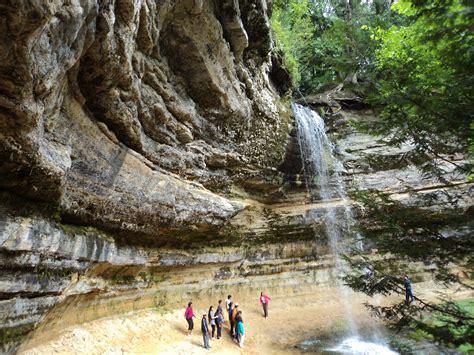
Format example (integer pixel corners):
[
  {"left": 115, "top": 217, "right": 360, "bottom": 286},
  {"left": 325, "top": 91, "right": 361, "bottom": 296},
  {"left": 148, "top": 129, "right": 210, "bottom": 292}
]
[{"left": 344, "top": 192, "right": 474, "bottom": 348}]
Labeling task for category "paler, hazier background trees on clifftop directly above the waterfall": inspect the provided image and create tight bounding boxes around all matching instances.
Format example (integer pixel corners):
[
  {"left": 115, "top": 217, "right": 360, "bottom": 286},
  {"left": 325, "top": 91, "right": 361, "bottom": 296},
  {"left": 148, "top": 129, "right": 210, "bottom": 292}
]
[{"left": 272, "top": 0, "right": 396, "bottom": 94}]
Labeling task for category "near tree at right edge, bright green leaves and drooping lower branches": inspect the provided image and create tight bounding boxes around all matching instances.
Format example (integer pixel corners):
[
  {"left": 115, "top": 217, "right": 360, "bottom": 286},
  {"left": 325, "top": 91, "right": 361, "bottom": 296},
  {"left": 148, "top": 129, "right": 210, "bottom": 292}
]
[{"left": 345, "top": 0, "right": 474, "bottom": 350}]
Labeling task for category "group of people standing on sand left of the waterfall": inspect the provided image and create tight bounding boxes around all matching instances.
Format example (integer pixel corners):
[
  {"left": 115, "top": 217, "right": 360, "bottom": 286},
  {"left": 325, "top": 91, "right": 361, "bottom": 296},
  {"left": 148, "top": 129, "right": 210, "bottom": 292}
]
[{"left": 184, "top": 292, "right": 271, "bottom": 349}]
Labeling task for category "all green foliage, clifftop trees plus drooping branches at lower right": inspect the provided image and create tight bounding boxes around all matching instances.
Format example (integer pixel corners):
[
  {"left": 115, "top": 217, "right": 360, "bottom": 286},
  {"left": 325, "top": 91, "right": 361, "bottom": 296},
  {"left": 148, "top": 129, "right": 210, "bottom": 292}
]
[{"left": 273, "top": 0, "right": 474, "bottom": 349}]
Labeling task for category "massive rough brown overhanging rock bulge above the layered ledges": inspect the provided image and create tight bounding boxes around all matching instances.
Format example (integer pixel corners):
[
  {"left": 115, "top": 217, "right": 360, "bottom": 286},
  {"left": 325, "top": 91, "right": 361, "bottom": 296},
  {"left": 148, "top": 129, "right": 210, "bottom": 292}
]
[{"left": 0, "top": 0, "right": 285, "bottom": 239}]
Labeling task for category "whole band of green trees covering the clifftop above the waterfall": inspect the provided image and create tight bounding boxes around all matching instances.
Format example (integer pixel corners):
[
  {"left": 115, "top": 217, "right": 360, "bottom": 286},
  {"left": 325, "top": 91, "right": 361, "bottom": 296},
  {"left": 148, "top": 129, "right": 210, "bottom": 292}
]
[{"left": 272, "top": 0, "right": 474, "bottom": 172}]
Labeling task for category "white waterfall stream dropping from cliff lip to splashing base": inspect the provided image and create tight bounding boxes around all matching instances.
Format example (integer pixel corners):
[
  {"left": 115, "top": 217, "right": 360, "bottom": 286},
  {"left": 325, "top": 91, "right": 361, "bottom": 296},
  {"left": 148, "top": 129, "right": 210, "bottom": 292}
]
[{"left": 293, "top": 104, "right": 395, "bottom": 354}]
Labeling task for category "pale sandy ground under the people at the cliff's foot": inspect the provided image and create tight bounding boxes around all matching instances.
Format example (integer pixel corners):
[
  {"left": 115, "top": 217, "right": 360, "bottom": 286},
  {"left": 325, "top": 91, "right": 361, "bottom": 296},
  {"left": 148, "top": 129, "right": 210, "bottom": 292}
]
[{"left": 20, "top": 288, "right": 472, "bottom": 355}]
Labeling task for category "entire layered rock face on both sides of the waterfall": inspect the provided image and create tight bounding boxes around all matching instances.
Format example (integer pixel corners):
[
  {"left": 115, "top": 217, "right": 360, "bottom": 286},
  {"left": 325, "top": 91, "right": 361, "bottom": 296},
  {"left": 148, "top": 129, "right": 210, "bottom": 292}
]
[{"left": 0, "top": 0, "right": 472, "bottom": 352}]
